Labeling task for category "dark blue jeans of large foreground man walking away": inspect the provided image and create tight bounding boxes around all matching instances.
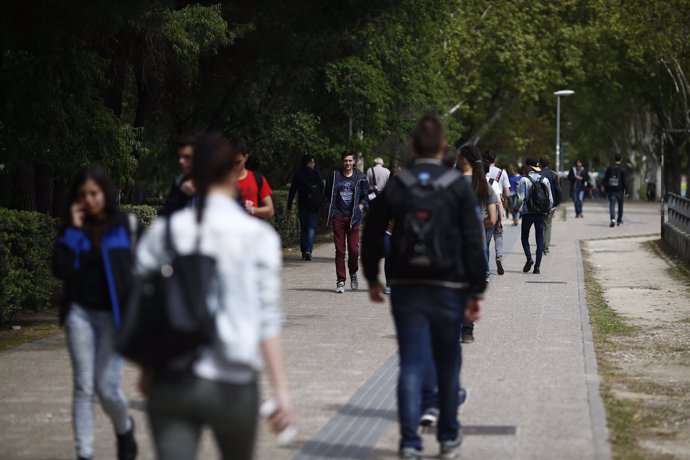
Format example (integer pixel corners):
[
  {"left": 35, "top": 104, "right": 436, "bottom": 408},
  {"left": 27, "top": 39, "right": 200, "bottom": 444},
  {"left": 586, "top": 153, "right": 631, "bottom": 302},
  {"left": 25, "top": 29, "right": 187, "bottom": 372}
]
[{"left": 391, "top": 285, "right": 467, "bottom": 449}]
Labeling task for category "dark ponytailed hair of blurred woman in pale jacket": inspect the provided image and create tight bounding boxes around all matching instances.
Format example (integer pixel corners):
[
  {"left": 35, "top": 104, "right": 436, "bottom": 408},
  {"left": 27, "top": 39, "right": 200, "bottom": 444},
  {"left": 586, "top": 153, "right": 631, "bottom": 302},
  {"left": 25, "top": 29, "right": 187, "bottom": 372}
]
[{"left": 192, "top": 134, "right": 236, "bottom": 223}]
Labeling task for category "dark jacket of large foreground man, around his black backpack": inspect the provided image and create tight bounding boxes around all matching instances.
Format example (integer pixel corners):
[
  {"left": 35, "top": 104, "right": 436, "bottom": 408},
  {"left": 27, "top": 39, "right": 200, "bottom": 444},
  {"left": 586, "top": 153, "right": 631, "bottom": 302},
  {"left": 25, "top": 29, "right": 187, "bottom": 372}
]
[{"left": 362, "top": 160, "right": 486, "bottom": 295}]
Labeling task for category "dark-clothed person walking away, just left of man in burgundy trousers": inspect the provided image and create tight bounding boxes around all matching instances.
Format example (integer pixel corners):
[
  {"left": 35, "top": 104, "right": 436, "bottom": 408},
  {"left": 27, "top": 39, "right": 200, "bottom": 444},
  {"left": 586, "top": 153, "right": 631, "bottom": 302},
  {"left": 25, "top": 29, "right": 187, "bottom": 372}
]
[{"left": 287, "top": 155, "right": 323, "bottom": 261}]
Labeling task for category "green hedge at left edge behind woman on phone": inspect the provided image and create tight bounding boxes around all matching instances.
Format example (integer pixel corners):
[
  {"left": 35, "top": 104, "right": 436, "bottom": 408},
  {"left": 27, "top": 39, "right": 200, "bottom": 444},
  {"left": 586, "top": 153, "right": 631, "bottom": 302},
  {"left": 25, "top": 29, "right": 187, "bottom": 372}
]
[{"left": 0, "top": 208, "right": 59, "bottom": 322}]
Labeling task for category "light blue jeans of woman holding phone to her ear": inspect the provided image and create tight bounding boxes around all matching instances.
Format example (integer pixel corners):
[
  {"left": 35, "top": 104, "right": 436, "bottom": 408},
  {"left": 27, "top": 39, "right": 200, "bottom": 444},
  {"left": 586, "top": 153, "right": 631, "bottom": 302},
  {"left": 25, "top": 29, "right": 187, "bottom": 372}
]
[{"left": 65, "top": 304, "right": 130, "bottom": 458}]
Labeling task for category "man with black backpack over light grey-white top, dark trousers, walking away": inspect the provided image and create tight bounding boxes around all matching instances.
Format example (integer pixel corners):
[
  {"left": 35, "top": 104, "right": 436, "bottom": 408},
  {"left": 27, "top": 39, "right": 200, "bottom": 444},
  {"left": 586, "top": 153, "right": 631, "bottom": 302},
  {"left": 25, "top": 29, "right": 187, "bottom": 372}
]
[{"left": 518, "top": 158, "right": 553, "bottom": 275}]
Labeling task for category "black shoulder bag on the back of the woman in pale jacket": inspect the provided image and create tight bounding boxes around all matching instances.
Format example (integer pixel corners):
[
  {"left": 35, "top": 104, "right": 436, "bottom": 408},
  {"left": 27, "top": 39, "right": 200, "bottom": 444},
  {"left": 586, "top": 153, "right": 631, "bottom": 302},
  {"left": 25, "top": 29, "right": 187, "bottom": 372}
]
[{"left": 117, "top": 218, "right": 216, "bottom": 369}]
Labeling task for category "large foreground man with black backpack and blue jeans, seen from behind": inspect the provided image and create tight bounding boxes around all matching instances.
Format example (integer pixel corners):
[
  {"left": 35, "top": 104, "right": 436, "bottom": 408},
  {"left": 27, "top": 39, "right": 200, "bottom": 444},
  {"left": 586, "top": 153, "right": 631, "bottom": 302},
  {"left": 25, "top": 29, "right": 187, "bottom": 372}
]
[{"left": 362, "top": 115, "right": 486, "bottom": 459}]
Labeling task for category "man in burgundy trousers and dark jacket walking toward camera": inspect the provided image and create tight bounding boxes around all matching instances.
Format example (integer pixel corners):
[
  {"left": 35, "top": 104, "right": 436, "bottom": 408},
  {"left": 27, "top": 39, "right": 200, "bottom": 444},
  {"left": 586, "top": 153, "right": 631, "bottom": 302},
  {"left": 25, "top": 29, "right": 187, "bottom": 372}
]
[{"left": 325, "top": 152, "right": 368, "bottom": 294}]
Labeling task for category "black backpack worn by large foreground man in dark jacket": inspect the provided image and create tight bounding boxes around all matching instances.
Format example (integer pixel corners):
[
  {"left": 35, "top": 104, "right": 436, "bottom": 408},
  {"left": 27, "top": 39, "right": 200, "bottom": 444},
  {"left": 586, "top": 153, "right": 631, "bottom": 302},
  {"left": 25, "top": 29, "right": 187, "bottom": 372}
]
[{"left": 394, "top": 169, "right": 462, "bottom": 279}]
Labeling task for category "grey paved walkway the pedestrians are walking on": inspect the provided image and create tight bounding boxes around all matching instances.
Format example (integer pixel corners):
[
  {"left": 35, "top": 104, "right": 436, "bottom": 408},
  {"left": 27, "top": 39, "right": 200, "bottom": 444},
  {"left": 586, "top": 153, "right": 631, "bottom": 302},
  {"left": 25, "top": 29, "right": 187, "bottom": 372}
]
[{"left": 0, "top": 201, "right": 659, "bottom": 460}]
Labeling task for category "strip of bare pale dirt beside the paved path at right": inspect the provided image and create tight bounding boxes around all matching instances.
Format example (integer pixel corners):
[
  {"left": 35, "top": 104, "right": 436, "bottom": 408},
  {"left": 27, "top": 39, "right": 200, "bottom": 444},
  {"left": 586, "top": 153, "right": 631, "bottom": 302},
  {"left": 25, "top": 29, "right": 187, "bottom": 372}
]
[{"left": 584, "top": 237, "right": 690, "bottom": 459}]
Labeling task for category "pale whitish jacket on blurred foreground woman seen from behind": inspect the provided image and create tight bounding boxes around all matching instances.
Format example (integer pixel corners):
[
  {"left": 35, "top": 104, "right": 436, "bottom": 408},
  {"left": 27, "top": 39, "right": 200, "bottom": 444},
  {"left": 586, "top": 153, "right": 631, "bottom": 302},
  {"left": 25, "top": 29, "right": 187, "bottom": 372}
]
[{"left": 136, "top": 194, "right": 283, "bottom": 383}]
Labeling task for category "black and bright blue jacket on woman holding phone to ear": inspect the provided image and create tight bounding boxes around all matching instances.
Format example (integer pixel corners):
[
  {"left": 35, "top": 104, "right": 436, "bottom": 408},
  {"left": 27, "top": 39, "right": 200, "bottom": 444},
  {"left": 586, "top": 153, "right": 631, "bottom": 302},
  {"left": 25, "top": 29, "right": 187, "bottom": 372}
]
[{"left": 53, "top": 213, "right": 142, "bottom": 329}]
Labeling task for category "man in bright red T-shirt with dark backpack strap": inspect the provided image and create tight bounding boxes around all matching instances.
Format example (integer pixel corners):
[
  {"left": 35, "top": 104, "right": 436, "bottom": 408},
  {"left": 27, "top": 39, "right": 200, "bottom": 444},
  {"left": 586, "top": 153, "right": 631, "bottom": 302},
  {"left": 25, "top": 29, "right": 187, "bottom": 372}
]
[{"left": 230, "top": 138, "right": 275, "bottom": 219}]
